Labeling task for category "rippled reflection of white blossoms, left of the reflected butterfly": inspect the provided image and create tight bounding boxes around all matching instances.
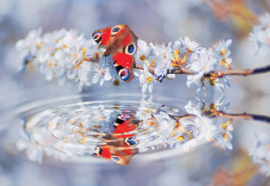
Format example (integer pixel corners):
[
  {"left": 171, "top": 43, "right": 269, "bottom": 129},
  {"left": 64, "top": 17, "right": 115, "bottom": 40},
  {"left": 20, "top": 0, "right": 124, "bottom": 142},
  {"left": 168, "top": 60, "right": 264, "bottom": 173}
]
[{"left": 17, "top": 105, "right": 116, "bottom": 163}]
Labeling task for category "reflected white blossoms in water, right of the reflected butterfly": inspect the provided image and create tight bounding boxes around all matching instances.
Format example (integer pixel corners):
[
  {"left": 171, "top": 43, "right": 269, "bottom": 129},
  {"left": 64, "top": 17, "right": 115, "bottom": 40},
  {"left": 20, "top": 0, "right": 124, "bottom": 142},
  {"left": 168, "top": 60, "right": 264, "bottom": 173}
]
[{"left": 136, "top": 96, "right": 233, "bottom": 152}]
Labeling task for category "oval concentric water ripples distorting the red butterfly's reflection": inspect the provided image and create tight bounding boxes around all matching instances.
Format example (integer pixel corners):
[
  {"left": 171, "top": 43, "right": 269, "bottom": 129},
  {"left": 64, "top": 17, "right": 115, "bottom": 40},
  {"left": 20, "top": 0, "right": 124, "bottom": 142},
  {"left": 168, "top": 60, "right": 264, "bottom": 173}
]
[{"left": 13, "top": 95, "right": 204, "bottom": 165}]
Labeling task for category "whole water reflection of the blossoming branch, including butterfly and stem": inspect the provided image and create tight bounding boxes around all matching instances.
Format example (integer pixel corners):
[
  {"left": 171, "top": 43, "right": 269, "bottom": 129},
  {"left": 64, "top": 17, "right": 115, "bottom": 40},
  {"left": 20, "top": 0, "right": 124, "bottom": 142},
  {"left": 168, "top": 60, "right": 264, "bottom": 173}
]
[{"left": 17, "top": 97, "right": 269, "bottom": 165}]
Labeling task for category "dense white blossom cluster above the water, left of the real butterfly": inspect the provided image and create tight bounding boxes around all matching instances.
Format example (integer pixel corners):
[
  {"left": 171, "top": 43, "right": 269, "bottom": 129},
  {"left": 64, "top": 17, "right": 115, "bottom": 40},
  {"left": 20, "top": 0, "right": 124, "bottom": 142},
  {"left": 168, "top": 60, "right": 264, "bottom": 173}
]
[{"left": 16, "top": 28, "right": 114, "bottom": 92}]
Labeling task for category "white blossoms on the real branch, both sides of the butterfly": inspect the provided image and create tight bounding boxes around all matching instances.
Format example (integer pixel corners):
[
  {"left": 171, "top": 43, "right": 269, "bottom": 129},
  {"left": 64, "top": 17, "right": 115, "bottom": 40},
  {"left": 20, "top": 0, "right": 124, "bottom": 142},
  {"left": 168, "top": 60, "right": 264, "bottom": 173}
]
[{"left": 16, "top": 28, "right": 232, "bottom": 93}]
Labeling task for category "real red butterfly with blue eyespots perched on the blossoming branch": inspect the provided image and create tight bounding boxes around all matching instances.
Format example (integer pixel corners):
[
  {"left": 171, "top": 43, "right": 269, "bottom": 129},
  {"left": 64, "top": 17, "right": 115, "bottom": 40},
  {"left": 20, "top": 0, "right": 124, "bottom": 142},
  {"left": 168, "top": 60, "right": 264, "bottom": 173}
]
[{"left": 92, "top": 24, "right": 138, "bottom": 82}]
